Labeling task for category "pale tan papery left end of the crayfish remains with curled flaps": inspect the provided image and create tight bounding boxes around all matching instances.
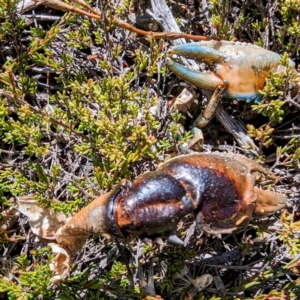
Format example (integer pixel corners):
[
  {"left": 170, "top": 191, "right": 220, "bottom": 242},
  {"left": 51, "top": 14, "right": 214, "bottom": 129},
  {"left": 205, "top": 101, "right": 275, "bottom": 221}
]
[{"left": 18, "top": 193, "right": 110, "bottom": 283}]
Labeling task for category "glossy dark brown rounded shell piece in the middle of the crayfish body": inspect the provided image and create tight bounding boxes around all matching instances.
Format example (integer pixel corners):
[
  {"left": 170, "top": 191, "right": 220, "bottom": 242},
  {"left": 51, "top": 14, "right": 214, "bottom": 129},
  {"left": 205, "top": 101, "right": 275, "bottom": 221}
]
[{"left": 114, "top": 171, "right": 196, "bottom": 237}]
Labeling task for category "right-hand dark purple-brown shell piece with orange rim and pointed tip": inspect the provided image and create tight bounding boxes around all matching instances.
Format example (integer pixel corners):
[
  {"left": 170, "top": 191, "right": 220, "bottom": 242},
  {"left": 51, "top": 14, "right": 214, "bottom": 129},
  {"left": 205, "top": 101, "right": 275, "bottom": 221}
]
[{"left": 158, "top": 153, "right": 286, "bottom": 234}]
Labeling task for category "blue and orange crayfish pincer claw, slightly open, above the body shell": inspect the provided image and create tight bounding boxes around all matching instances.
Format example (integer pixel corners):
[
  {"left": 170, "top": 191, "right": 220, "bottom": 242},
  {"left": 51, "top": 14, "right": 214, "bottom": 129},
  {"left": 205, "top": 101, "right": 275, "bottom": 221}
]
[{"left": 167, "top": 40, "right": 295, "bottom": 102}]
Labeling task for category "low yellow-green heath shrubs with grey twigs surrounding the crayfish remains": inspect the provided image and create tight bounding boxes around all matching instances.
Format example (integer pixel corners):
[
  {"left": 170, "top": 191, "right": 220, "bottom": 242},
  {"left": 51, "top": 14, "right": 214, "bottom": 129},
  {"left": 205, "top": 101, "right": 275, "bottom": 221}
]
[{"left": 0, "top": 0, "right": 300, "bottom": 300}]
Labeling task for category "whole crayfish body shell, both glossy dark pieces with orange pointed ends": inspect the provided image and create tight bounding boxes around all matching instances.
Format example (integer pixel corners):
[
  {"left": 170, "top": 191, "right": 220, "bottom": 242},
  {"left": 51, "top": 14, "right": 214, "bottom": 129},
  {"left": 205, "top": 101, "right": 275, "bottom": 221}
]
[{"left": 79, "top": 153, "right": 287, "bottom": 244}]
